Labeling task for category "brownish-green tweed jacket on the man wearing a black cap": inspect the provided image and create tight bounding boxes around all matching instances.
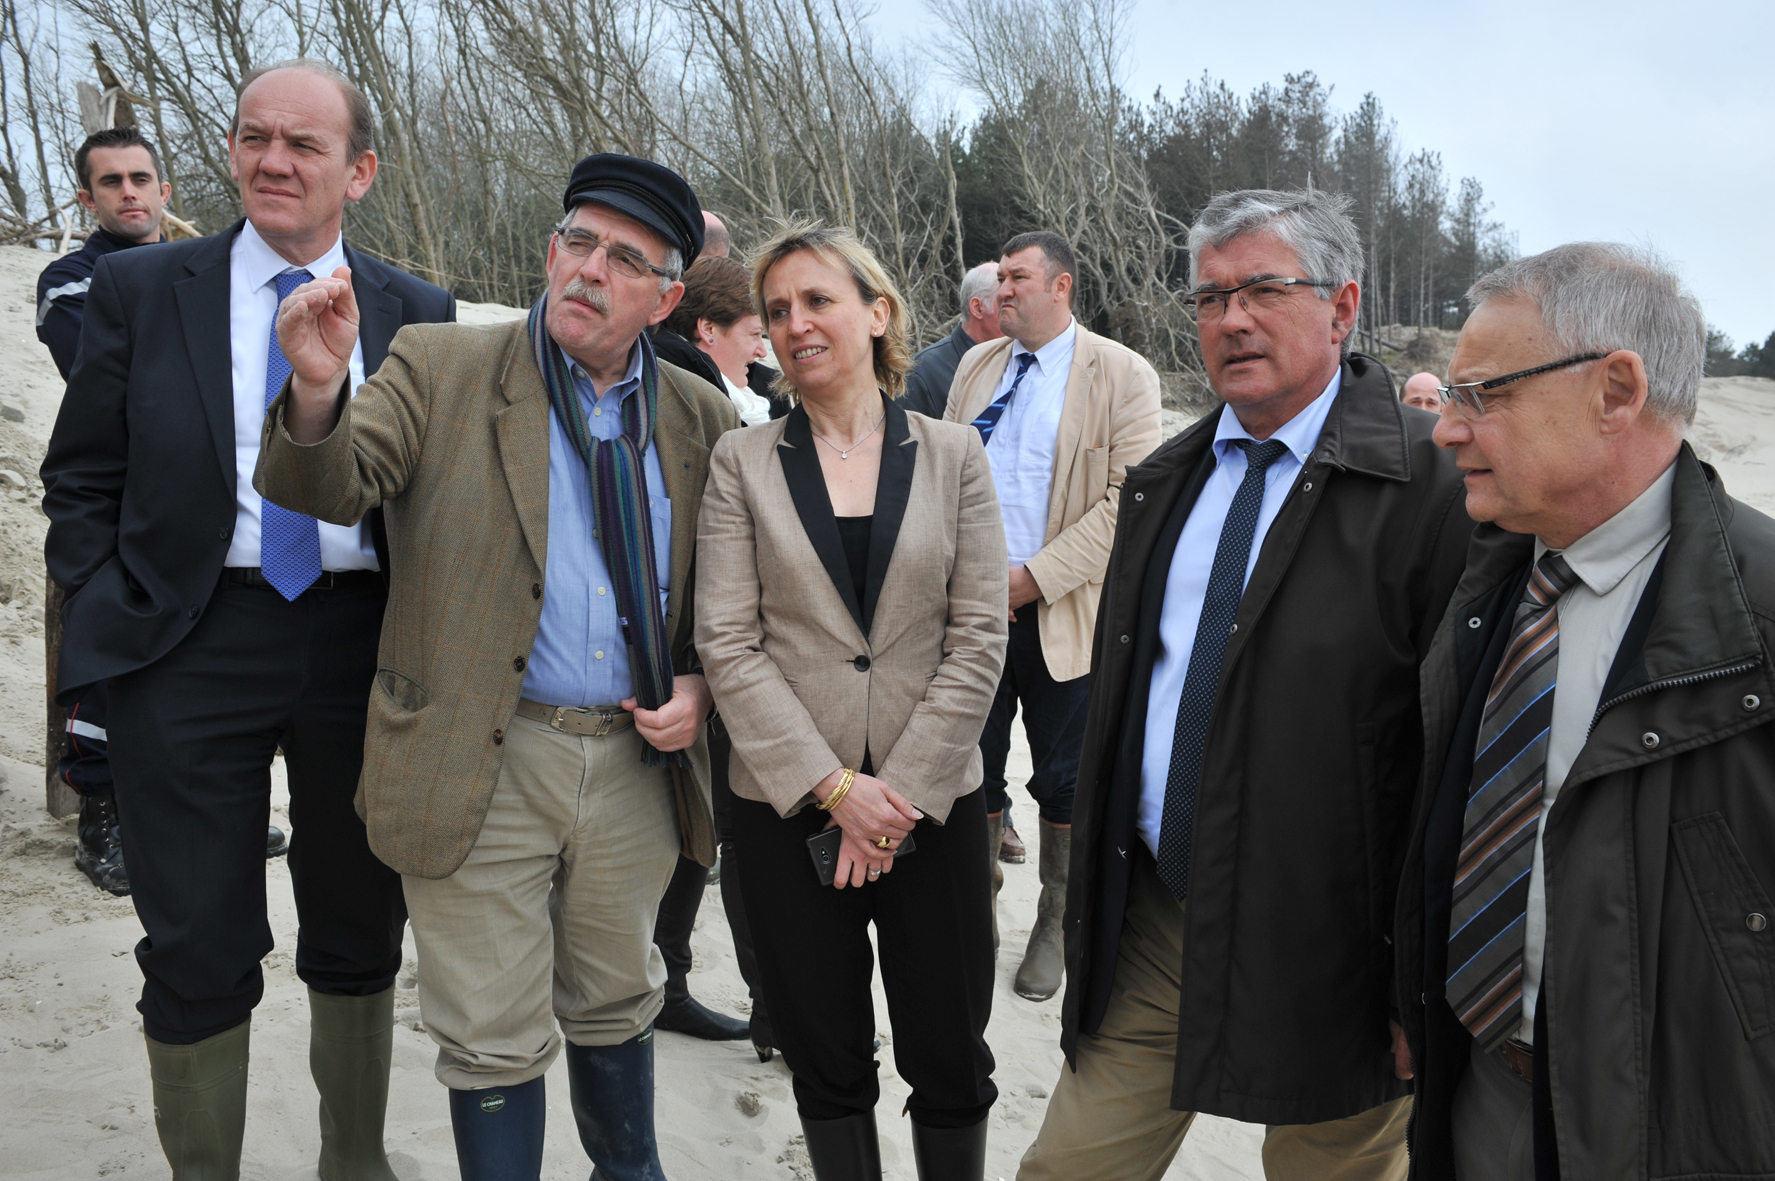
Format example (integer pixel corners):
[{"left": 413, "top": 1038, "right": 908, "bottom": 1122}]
[{"left": 254, "top": 320, "right": 740, "bottom": 877}]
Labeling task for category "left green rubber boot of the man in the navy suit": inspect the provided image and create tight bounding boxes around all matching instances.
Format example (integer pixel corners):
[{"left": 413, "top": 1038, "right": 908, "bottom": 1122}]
[{"left": 142, "top": 1021, "right": 252, "bottom": 1181}]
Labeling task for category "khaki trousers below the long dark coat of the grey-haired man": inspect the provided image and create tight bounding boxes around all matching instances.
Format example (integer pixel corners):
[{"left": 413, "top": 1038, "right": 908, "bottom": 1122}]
[{"left": 1017, "top": 858, "right": 1411, "bottom": 1181}]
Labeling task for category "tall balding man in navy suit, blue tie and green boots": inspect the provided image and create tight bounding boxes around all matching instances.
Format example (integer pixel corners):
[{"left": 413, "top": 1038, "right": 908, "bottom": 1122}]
[{"left": 43, "top": 60, "right": 456, "bottom": 1181}]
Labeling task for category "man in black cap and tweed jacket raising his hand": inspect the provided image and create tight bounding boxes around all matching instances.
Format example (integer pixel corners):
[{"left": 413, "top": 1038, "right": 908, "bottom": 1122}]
[{"left": 256, "top": 153, "right": 740, "bottom": 1181}]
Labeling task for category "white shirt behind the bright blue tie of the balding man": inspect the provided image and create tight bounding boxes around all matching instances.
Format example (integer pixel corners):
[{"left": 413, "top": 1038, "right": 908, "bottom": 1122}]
[{"left": 224, "top": 222, "right": 380, "bottom": 570}]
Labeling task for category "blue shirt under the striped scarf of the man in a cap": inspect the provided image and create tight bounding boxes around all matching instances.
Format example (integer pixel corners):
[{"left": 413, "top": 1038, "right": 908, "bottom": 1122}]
[{"left": 524, "top": 343, "right": 671, "bottom": 707}]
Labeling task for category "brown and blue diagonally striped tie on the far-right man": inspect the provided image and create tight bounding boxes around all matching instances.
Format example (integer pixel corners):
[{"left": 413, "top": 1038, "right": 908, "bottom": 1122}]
[{"left": 1448, "top": 551, "right": 1578, "bottom": 1051}]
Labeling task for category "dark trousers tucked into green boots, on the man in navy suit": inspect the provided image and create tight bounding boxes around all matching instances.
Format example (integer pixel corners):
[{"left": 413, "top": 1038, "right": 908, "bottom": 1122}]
[{"left": 108, "top": 581, "right": 406, "bottom": 1044}]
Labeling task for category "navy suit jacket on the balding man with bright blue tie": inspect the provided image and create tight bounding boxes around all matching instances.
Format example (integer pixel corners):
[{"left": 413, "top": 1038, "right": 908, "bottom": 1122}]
[{"left": 43, "top": 222, "right": 456, "bottom": 705}]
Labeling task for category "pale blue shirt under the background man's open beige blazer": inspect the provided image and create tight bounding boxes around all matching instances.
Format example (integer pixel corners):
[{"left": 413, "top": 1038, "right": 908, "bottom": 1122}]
[{"left": 987, "top": 320, "right": 1079, "bottom": 567}]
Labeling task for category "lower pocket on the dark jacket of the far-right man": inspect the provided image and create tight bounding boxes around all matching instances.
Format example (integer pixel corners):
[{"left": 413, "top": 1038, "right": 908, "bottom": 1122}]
[{"left": 1670, "top": 812, "right": 1775, "bottom": 1037}]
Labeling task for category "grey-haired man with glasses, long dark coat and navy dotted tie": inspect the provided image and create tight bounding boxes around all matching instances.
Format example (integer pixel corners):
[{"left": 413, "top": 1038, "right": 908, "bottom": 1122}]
[{"left": 1017, "top": 190, "right": 1471, "bottom": 1181}]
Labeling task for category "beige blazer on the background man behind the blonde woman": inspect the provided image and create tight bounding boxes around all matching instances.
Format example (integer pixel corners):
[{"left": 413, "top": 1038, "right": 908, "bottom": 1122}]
[{"left": 943, "top": 325, "right": 1159, "bottom": 680}]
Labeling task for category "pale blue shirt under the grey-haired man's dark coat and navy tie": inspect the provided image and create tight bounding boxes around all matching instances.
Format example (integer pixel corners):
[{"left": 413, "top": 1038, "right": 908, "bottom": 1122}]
[{"left": 1140, "top": 368, "right": 1344, "bottom": 856}]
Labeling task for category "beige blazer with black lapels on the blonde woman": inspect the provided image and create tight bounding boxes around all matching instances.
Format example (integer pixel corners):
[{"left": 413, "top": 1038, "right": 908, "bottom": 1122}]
[{"left": 696, "top": 403, "right": 1008, "bottom": 824}]
